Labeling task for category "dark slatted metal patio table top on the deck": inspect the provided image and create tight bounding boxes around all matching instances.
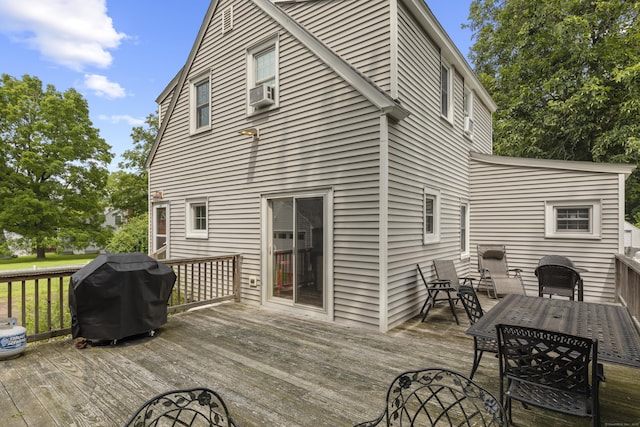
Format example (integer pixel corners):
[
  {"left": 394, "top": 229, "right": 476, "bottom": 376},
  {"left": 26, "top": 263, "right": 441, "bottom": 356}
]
[{"left": 466, "top": 295, "right": 640, "bottom": 368}]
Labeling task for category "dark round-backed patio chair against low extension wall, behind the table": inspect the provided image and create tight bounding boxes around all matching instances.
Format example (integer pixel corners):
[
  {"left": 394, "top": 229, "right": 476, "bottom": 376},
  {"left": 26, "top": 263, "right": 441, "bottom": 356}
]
[{"left": 535, "top": 255, "right": 584, "bottom": 301}]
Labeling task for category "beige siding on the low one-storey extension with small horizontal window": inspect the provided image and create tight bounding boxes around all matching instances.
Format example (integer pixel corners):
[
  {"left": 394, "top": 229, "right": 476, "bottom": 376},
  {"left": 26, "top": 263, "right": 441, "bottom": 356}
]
[{"left": 470, "top": 160, "right": 624, "bottom": 302}]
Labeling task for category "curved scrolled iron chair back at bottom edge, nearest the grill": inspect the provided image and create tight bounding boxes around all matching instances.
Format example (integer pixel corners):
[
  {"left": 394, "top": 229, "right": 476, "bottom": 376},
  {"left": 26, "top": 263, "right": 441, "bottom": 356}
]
[{"left": 125, "top": 388, "right": 237, "bottom": 427}]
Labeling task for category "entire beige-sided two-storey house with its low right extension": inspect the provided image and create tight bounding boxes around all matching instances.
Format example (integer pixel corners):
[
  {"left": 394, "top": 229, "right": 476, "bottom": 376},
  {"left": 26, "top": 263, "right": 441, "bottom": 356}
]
[{"left": 147, "top": 0, "right": 632, "bottom": 331}]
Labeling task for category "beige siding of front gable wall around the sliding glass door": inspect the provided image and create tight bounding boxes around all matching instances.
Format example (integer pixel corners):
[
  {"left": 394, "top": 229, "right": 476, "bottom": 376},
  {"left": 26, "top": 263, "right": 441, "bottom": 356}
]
[{"left": 149, "top": 1, "right": 380, "bottom": 327}]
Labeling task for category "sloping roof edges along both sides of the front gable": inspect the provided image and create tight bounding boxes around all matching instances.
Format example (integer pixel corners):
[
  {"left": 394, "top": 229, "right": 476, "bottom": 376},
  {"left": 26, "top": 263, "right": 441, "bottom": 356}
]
[{"left": 146, "top": 0, "right": 409, "bottom": 167}]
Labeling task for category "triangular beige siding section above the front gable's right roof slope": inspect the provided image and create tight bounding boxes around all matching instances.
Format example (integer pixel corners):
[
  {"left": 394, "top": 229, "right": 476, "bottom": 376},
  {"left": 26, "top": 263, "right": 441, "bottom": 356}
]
[{"left": 278, "top": 0, "right": 391, "bottom": 92}]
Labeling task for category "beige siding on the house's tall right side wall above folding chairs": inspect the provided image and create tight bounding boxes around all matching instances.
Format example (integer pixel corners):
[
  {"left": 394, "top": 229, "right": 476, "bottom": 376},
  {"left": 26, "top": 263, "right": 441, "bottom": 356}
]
[{"left": 388, "top": 4, "right": 491, "bottom": 327}]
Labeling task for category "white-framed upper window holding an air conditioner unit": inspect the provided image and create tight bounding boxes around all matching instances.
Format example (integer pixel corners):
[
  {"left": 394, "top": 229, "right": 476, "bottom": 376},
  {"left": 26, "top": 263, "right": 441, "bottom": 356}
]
[{"left": 247, "top": 37, "right": 279, "bottom": 114}]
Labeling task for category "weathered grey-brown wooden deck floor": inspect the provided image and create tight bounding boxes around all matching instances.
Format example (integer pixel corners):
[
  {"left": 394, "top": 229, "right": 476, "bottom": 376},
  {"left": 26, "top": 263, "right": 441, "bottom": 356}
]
[{"left": 0, "top": 299, "right": 640, "bottom": 427}]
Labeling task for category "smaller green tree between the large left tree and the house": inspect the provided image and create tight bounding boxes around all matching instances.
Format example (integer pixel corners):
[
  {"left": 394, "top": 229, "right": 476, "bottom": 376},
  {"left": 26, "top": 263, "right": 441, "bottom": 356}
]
[{"left": 108, "top": 114, "right": 158, "bottom": 218}]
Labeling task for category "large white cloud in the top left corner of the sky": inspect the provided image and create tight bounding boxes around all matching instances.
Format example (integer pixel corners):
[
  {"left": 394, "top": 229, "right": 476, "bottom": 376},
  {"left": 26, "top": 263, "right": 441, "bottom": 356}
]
[{"left": 0, "top": 0, "right": 127, "bottom": 71}]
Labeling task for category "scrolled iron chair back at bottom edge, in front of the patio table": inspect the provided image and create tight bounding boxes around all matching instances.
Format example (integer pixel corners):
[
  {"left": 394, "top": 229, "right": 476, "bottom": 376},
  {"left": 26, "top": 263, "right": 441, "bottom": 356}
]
[{"left": 356, "top": 368, "right": 506, "bottom": 427}]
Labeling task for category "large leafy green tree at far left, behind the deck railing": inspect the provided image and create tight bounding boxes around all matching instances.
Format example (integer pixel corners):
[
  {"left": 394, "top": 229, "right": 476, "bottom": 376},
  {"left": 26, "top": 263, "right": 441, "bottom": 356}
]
[{"left": 0, "top": 74, "right": 113, "bottom": 258}]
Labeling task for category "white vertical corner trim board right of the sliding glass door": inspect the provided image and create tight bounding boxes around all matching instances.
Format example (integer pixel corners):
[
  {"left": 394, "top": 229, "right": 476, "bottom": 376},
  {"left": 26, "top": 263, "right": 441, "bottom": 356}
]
[{"left": 378, "top": 114, "right": 389, "bottom": 332}]
